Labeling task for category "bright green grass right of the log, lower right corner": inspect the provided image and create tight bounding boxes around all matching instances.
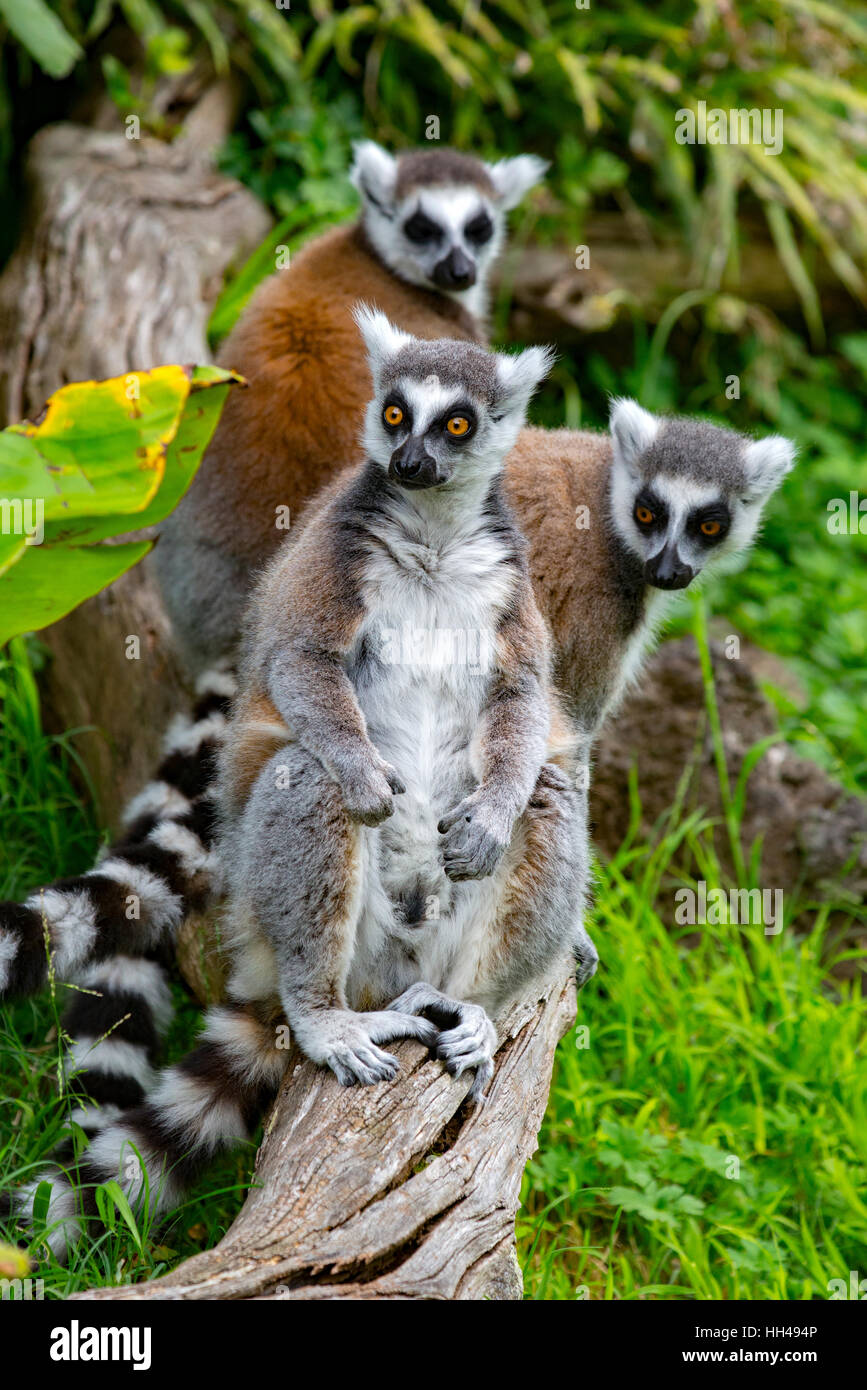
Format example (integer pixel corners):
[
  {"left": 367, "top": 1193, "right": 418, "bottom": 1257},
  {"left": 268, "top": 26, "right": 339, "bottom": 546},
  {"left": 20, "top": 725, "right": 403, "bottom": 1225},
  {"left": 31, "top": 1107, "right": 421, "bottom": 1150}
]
[{"left": 518, "top": 811, "right": 867, "bottom": 1300}]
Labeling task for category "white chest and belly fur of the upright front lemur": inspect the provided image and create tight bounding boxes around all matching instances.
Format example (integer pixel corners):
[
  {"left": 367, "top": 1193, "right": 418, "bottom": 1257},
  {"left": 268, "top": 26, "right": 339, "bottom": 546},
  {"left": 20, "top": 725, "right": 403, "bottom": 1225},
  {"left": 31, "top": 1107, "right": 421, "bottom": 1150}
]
[{"left": 347, "top": 493, "right": 514, "bottom": 984}]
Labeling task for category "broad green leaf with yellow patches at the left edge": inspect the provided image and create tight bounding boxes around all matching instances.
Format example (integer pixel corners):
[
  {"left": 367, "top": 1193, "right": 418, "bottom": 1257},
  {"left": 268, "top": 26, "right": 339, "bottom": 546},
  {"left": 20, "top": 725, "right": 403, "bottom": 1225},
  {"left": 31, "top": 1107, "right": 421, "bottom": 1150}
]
[{"left": 0, "top": 367, "right": 238, "bottom": 645}]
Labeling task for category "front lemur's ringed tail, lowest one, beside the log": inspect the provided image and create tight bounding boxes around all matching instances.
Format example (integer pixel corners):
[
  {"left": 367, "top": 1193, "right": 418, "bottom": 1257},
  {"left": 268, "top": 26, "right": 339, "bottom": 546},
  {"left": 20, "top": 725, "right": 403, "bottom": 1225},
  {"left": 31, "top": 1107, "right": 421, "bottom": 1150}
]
[{"left": 10, "top": 1004, "right": 289, "bottom": 1259}]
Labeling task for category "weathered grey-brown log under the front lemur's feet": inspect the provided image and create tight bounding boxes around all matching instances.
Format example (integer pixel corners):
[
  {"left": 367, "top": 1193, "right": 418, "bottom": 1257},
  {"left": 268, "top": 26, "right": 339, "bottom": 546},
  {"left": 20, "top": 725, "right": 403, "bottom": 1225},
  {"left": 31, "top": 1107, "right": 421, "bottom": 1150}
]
[{"left": 74, "top": 977, "right": 575, "bottom": 1300}]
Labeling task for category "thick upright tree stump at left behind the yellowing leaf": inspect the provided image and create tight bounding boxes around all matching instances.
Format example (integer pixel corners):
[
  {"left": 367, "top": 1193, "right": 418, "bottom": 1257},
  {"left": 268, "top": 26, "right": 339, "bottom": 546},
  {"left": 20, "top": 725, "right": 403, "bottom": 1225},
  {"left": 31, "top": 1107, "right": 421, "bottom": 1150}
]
[{"left": 0, "top": 122, "right": 270, "bottom": 826}]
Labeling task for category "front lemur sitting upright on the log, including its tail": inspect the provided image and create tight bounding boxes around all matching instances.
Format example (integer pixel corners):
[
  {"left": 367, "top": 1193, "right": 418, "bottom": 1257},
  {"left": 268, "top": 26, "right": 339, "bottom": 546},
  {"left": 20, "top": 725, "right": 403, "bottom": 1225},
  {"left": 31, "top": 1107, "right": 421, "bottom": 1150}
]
[{"left": 6, "top": 322, "right": 596, "bottom": 1254}]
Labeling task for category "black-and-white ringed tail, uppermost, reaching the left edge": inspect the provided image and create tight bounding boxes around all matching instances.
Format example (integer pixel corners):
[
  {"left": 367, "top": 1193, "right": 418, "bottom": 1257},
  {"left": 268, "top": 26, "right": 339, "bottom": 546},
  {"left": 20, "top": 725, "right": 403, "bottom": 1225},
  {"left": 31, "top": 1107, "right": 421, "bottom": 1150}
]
[{"left": 0, "top": 669, "right": 235, "bottom": 999}]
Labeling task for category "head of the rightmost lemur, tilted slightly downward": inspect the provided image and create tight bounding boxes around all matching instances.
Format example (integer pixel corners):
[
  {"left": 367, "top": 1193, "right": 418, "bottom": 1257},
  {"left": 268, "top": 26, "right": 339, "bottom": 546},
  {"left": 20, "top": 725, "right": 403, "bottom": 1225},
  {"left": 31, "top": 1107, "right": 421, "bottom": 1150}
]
[{"left": 610, "top": 400, "right": 795, "bottom": 589}]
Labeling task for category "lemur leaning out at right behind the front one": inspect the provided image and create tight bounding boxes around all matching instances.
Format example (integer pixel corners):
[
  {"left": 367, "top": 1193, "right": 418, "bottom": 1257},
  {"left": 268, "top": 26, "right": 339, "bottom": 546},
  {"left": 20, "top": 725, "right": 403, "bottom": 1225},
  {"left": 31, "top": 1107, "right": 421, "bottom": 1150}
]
[{"left": 506, "top": 399, "right": 795, "bottom": 741}]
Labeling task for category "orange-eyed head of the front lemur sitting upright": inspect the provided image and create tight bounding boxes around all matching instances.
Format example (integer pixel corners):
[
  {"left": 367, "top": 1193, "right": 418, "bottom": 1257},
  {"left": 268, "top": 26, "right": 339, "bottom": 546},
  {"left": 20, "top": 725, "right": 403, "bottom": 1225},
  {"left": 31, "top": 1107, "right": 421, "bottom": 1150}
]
[{"left": 356, "top": 306, "right": 552, "bottom": 492}]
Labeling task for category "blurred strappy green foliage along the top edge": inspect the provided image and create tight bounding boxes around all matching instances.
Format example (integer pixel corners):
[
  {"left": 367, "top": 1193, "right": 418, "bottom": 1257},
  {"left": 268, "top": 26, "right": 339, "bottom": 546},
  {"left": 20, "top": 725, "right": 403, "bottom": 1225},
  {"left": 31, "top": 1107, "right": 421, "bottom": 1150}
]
[{"left": 3, "top": 0, "right": 867, "bottom": 322}]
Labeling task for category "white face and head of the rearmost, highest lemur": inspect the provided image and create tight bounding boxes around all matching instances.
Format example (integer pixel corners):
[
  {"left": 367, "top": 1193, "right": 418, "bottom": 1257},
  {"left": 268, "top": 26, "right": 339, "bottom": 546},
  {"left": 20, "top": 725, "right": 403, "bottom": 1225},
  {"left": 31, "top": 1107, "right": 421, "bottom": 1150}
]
[{"left": 352, "top": 140, "right": 546, "bottom": 311}]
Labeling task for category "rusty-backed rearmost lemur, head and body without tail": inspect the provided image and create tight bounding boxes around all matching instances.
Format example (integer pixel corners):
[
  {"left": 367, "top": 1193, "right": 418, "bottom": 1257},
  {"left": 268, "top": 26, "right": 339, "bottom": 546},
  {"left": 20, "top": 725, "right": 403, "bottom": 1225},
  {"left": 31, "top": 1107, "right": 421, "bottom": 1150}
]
[{"left": 154, "top": 140, "right": 546, "bottom": 671}]
